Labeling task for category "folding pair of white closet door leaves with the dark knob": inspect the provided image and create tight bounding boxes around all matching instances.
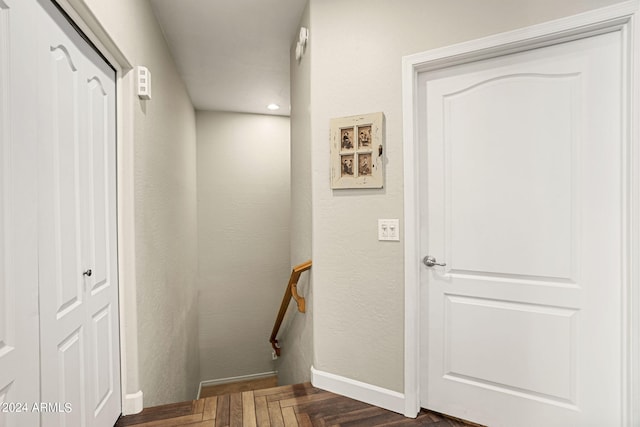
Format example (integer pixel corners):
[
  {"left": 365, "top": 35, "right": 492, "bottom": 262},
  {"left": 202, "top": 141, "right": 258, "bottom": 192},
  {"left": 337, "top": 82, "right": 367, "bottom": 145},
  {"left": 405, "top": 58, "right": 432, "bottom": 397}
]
[{"left": 38, "top": 0, "right": 121, "bottom": 427}]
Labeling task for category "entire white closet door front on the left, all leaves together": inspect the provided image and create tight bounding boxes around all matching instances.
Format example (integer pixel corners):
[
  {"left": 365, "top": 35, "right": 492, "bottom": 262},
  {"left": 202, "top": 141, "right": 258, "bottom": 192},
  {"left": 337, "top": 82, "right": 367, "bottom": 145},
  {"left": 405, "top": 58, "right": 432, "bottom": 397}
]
[{"left": 0, "top": 0, "right": 121, "bottom": 427}]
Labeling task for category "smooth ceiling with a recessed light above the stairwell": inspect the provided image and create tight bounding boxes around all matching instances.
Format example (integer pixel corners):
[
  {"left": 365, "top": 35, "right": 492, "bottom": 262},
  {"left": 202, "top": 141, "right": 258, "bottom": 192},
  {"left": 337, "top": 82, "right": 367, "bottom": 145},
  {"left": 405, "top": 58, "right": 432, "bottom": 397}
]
[{"left": 150, "top": 0, "right": 306, "bottom": 116}]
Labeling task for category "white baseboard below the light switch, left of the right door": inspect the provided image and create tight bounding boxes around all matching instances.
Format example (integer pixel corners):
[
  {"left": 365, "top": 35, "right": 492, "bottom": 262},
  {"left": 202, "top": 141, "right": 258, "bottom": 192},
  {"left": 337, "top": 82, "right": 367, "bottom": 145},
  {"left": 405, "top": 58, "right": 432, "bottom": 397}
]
[{"left": 311, "top": 366, "right": 405, "bottom": 415}]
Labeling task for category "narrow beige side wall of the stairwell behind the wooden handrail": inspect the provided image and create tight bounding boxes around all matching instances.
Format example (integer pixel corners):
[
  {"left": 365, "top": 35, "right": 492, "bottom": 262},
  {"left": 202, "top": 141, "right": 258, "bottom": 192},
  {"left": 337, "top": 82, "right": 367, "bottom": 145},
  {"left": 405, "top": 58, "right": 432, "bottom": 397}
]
[{"left": 276, "top": 2, "right": 313, "bottom": 384}]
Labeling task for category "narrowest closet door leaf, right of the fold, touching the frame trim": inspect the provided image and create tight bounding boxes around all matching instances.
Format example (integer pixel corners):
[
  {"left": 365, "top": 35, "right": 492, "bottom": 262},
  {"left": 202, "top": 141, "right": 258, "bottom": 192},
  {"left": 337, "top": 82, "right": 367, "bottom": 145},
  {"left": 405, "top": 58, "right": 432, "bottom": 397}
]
[{"left": 83, "top": 61, "right": 120, "bottom": 426}]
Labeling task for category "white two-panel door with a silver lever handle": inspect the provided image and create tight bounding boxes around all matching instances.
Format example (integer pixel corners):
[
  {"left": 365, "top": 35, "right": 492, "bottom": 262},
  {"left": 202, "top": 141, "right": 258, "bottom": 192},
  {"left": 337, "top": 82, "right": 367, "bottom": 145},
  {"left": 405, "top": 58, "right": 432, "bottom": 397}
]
[{"left": 419, "top": 33, "right": 624, "bottom": 427}]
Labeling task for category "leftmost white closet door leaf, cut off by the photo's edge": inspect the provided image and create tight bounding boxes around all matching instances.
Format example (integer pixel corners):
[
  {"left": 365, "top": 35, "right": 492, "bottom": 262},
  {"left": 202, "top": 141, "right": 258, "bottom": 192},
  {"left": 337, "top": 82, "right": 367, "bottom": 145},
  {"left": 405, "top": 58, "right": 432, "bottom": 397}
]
[{"left": 0, "top": 0, "right": 40, "bottom": 427}]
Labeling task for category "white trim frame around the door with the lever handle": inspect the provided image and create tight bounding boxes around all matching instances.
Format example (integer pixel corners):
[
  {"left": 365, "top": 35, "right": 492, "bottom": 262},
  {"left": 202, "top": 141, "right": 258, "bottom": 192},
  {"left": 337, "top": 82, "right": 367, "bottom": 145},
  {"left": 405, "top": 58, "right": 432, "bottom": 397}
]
[{"left": 402, "top": 0, "right": 640, "bottom": 426}]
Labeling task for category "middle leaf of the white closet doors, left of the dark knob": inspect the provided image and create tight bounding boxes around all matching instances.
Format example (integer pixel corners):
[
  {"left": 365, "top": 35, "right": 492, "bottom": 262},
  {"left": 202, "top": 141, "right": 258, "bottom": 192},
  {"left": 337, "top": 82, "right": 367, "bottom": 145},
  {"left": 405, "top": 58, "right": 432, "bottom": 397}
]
[{"left": 36, "top": 7, "right": 91, "bottom": 427}]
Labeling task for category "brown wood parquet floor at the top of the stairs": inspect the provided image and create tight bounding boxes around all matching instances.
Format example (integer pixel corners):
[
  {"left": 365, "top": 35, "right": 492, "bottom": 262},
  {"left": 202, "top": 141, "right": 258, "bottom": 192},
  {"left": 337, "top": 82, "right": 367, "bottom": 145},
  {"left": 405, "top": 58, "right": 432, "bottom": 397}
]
[{"left": 115, "top": 383, "right": 478, "bottom": 427}]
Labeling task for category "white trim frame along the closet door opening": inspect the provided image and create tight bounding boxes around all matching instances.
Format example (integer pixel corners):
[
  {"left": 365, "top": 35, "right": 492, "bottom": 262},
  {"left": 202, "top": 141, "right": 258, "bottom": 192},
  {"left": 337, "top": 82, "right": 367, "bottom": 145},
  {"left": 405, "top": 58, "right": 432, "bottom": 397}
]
[{"left": 51, "top": 0, "right": 143, "bottom": 415}]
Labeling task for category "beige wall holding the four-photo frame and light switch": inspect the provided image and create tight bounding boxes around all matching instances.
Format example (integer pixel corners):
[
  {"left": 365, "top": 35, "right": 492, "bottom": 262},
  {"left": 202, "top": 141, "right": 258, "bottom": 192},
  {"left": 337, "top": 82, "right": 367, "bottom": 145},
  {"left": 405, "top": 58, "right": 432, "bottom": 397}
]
[{"left": 310, "top": 0, "right": 615, "bottom": 392}]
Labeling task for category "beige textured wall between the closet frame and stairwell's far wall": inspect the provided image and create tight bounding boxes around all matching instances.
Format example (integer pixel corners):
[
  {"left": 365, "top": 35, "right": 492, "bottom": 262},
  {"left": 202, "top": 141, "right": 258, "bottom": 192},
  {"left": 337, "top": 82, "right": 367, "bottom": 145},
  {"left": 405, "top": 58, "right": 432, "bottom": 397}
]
[{"left": 84, "top": 0, "right": 199, "bottom": 407}]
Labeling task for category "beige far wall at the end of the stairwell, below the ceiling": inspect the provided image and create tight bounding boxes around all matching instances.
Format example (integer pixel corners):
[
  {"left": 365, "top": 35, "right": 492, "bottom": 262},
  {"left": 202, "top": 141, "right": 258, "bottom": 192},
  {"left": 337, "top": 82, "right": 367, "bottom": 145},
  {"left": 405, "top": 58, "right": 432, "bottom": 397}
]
[{"left": 196, "top": 111, "right": 290, "bottom": 381}]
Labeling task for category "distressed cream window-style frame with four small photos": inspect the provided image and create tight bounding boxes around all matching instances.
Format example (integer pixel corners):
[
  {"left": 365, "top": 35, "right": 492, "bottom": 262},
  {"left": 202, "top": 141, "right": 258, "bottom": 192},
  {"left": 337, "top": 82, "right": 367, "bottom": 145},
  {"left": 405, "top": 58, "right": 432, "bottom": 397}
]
[{"left": 330, "top": 113, "right": 384, "bottom": 189}]
